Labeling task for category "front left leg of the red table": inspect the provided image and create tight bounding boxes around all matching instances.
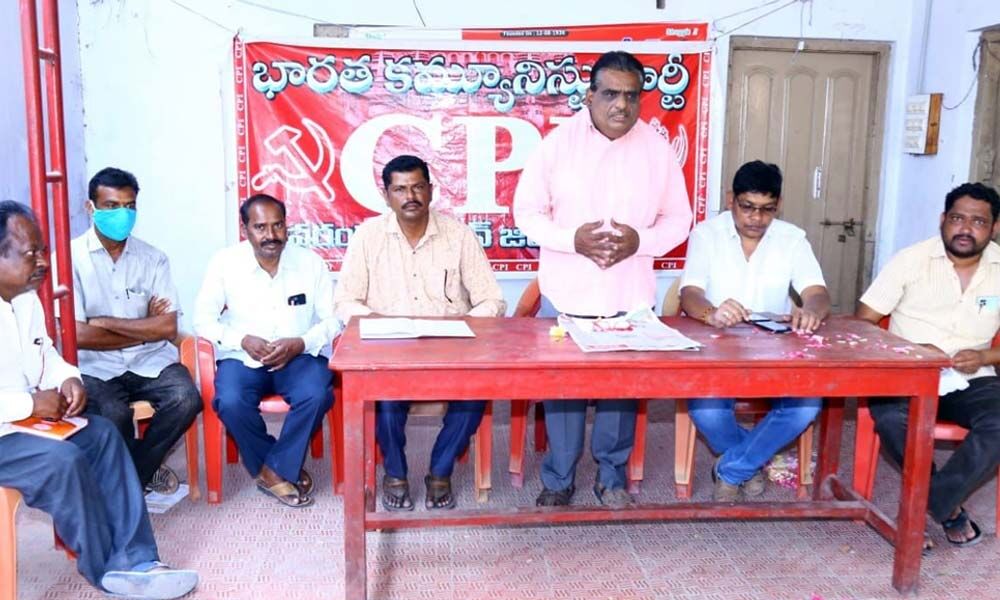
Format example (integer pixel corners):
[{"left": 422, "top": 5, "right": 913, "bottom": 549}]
[{"left": 341, "top": 386, "right": 368, "bottom": 600}]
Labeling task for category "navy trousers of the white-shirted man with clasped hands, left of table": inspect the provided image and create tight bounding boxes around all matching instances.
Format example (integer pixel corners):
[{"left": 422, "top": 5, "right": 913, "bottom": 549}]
[{"left": 212, "top": 354, "right": 333, "bottom": 482}]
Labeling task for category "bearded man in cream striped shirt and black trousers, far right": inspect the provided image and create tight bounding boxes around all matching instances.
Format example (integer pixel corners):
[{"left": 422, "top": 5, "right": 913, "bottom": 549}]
[{"left": 857, "top": 183, "right": 1000, "bottom": 546}]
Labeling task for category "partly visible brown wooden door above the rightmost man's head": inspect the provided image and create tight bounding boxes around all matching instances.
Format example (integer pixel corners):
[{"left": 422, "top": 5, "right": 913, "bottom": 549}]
[{"left": 969, "top": 27, "right": 1000, "bottom": 181}]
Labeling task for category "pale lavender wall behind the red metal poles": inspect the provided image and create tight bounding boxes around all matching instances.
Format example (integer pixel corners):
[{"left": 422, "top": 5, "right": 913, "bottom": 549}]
[{"left": 0, "top": 0, "right": 87, "bottom": 233}]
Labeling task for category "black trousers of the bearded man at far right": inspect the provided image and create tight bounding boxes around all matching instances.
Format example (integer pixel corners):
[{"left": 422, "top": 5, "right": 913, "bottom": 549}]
[{"left": 869, "top": 376, "right": 1000, "bottom": 523}]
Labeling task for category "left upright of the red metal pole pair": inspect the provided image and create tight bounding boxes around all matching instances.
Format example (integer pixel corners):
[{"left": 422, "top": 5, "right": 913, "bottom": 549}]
[{"left": 20, "top": 0, "right": 56, "bottom": 337}]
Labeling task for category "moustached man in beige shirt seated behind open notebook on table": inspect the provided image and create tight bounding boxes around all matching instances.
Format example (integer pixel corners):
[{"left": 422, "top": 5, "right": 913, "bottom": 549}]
[{"left": 334, "top": 155, "right": 507, "bottom": 511}]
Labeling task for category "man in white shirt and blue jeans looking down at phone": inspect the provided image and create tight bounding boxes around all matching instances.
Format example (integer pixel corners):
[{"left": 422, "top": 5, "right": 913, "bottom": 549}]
[{"left": 681, "top": 160, "right": 830, "bottom": 502}]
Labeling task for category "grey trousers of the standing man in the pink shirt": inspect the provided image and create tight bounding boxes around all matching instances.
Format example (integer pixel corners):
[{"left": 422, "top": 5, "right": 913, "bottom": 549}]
[{"left": 536, "top": 296, "right": 639, "bottom": 490}]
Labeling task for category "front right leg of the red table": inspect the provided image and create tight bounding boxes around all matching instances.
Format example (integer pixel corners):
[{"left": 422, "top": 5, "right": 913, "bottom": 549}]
[{"left": 892, "top": 394, "right": 938, "bottom": 594}]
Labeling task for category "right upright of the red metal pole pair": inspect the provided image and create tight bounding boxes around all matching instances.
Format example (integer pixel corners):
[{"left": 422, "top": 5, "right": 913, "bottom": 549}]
[{"left": 42, "top": 0, "right": 77, "bottom": 364}]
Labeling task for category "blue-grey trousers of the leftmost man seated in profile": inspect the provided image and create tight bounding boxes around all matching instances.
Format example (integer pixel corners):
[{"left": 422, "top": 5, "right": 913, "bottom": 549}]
[{"left": 0, "top": 415, "right": 159, "bottom": 587}]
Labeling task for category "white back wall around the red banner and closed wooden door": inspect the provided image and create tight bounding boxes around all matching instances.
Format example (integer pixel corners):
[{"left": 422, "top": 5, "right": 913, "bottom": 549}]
[{"left": 68, "top": 0, "right": 1000, "bottom": 324}]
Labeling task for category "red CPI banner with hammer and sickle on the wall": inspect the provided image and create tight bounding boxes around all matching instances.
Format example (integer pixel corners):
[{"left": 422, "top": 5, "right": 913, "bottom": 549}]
[{"left": 234, "top": 30, "right": 711, "bottom": 272}]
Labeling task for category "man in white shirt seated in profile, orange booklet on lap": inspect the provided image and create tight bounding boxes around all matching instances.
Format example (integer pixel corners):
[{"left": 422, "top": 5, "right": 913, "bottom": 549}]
[{"left": 0, "top": 200, "right": 198, "bottom": 598}]
